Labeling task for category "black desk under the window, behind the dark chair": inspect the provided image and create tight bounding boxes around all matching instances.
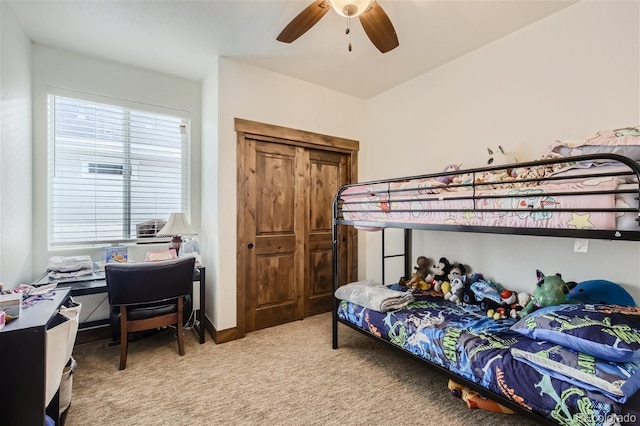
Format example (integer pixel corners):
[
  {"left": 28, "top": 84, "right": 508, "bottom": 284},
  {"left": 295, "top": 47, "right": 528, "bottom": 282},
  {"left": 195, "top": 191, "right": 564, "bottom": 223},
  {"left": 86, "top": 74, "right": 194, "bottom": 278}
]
[{"left": 34, "top": 266, "right": 206, "bottom": 343}]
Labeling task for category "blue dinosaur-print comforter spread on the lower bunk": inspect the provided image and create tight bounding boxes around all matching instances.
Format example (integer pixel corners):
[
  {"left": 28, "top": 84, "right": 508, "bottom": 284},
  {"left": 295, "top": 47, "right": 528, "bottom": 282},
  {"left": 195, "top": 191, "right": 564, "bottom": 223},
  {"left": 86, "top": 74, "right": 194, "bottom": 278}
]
[{"left": 338, "top": 296, "right": 636, "bottom": 426}]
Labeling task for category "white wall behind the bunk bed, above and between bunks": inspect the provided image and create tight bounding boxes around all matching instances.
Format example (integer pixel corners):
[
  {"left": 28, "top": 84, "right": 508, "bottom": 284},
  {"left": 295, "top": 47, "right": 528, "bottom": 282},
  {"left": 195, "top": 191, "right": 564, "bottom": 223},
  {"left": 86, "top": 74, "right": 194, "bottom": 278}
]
[{"left": 360, "top": 1, "right": 640, "bottom": 300}]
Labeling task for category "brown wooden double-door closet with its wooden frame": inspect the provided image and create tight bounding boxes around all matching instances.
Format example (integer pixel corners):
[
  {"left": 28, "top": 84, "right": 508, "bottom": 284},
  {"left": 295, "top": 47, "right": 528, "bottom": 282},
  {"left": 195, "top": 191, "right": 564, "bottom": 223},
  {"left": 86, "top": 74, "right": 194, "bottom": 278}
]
[{"left": 235, "top": 119, "right": 359, "bottom": 337}]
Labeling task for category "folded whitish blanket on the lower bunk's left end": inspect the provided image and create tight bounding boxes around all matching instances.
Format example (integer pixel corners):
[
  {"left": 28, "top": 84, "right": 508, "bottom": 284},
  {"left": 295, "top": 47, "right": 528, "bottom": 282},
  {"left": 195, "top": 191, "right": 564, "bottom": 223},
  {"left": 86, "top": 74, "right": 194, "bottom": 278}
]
[{"left": 335, "top": 281, "right": 414, "bottom": 312}]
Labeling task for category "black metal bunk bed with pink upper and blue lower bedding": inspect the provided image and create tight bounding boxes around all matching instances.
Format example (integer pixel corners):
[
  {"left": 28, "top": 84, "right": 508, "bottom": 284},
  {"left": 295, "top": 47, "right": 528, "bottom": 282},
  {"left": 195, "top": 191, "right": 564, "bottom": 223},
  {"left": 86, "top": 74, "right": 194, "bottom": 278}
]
[{"left": 332, "top": 141, "right": 640, "bottom": 425}]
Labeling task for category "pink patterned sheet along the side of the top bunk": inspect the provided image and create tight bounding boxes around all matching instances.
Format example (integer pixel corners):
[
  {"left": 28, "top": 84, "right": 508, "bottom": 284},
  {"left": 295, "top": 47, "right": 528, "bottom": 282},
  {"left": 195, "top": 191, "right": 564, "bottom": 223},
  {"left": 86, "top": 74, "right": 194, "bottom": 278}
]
[{"left": 340, "top": 176, "right": 639, "bottom": 230}]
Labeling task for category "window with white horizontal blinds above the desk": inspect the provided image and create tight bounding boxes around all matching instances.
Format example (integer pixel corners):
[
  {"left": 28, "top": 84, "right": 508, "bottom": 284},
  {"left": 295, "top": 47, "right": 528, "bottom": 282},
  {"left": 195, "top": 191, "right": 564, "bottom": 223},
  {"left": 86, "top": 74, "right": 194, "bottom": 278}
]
[{"left": 48, "top": 88, "right": 190, "bottom": 247}]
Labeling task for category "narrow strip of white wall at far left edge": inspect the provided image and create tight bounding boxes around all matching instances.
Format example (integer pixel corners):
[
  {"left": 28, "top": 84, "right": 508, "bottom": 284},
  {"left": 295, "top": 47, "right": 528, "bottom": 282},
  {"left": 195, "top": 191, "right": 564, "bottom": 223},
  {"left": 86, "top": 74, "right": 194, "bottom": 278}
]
[{"left": 0, "top": 2, "right": 33, "bottom": 289}]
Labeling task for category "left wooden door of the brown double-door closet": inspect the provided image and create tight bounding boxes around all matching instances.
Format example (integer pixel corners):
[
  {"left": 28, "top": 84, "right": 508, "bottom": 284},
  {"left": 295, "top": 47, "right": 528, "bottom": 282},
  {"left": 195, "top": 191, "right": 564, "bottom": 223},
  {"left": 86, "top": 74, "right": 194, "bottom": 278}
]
[{"left": 242, "top": 141, "right": 304, "bottom": 331}]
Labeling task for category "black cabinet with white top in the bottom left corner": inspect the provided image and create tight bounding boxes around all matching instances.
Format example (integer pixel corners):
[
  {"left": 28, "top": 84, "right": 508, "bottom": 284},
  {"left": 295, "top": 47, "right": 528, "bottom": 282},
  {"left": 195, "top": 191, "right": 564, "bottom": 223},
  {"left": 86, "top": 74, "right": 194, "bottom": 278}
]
[{"left": 0, "top": 289, "right": 69, "bottom": 425}]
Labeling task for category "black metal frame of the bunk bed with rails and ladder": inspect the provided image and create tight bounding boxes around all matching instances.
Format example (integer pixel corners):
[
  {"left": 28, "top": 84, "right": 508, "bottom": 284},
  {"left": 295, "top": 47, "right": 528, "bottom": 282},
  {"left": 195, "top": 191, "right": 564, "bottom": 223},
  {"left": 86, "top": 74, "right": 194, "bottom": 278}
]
[{"left": 332, "top": 154, "right": 640, "bottom": 425}]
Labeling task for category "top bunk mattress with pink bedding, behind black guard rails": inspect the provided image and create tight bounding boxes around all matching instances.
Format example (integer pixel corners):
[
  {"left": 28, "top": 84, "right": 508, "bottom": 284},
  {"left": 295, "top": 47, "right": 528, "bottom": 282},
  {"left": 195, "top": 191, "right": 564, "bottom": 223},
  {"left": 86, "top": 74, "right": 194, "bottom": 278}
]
[{"left": 335, "top": 151, "right": 640, "bottom": 236}]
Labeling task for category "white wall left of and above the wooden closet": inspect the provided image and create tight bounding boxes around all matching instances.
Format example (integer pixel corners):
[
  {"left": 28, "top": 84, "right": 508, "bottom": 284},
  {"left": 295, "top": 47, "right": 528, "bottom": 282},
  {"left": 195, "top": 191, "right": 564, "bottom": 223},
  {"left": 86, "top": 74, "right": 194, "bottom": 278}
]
[{"left": 202, "top": 58, "right": 364, "bottom": 330}]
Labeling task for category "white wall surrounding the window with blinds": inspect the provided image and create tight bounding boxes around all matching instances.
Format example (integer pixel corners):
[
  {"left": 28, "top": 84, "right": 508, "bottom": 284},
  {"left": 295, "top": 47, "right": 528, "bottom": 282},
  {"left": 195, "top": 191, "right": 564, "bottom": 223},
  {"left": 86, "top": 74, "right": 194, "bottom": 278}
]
[{"left": 32, "top": 44, "right": 201, "bottom": 272}]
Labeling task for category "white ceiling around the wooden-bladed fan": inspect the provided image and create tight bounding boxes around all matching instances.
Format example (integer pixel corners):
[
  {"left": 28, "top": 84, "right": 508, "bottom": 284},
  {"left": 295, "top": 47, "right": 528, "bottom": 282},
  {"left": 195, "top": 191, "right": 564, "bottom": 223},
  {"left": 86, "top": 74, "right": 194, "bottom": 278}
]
[{"left": 2, "top": 0, "right": 575, "bottom": 99}]
